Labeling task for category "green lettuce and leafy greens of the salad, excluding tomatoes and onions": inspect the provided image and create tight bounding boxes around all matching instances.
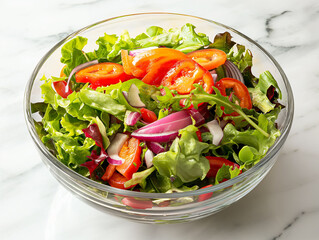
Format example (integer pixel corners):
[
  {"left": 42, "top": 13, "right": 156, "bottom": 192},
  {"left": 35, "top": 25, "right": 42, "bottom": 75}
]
[{"left": 32, "top": 24, "right": 282, "bottom": 192}]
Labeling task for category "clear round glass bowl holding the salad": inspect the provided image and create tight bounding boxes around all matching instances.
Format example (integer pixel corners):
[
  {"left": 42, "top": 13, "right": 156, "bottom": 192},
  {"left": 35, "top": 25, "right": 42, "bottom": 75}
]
[{"left": 24, "top": 13, "right": 294, "bottom": 223}]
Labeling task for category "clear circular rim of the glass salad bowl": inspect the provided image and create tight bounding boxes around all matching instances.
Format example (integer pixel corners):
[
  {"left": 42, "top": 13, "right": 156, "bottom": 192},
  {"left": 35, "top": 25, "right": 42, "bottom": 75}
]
[{"left": 24, "top": 12, "right": 294, "bottom": 199}]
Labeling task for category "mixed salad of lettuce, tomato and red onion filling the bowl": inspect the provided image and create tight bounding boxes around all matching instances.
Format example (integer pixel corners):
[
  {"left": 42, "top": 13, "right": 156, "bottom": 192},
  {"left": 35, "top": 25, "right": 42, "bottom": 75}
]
[{"left": 31, "top": 23, "right": 283, "bottom": 193}]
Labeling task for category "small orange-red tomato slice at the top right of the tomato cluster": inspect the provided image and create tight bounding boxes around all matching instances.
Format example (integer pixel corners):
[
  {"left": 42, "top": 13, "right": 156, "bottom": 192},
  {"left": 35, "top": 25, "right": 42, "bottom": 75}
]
[{"left": 187, "top": 49, "right": 227, "bottom": 70}]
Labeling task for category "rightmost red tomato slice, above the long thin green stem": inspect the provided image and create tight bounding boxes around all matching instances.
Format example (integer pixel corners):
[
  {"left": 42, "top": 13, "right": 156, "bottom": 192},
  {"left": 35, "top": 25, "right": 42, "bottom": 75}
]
[{"left": 216, "top": 78, "right": 252, "bottom": 109}]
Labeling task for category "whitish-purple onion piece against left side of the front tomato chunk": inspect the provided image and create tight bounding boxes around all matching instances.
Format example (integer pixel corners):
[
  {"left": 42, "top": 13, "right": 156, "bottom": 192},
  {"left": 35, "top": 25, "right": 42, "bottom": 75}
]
[{"left": 107, "top": 133, "right": 129, "bottom": 165}]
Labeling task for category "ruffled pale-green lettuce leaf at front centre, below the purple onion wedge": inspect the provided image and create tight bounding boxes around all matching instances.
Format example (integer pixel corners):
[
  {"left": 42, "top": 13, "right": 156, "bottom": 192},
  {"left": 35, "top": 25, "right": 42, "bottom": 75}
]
[{"left": 153, "top": 125, "right": 209, "bottom": 183}]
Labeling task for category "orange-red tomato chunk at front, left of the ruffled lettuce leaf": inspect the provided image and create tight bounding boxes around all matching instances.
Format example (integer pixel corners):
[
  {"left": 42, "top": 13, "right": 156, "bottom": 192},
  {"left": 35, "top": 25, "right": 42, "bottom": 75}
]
[{"left": 116, "top": 137, "right": 142, "bottom": 179}]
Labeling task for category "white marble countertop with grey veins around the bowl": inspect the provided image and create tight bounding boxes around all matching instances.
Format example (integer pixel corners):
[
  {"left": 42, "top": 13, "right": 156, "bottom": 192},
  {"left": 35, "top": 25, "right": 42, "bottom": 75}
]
[{"left": 0, "top": 0, "right": 319, "bottom": 240}]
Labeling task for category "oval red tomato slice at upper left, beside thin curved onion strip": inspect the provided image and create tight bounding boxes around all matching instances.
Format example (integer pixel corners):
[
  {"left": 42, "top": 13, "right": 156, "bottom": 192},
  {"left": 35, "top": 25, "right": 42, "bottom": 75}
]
[{"left": 75, "top": 62, "right": 130, "bottom": 89}]
